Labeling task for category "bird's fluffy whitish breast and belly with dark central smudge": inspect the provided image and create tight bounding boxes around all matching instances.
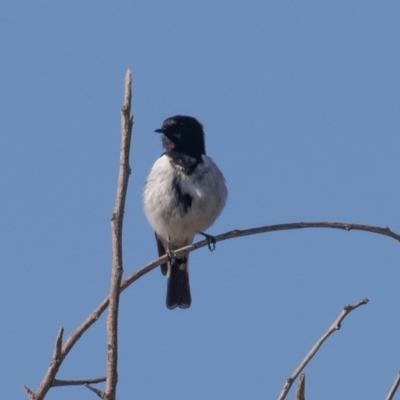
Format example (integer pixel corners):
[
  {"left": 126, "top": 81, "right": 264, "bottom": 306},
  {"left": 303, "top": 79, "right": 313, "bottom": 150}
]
[{"left": 143, "top": 154, "right": 227, "bottom": 248}]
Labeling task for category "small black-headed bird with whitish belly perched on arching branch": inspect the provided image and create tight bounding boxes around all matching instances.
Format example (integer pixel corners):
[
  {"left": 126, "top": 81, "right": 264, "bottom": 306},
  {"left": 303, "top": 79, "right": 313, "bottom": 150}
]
[{"left": 143, "top": 115, "right": 228, "bottom": 310}]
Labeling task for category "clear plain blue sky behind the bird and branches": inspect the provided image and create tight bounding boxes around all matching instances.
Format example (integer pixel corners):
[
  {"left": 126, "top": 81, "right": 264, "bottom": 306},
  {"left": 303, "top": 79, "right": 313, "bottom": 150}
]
[{"left": 0, "top": 0, "right": 400, "bottom": 400}]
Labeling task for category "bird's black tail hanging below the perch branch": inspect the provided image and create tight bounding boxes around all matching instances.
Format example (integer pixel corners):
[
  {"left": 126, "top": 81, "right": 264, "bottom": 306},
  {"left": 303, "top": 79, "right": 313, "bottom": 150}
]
[{"left": 167, "top": 257, "right": 192, "bottom": 310}]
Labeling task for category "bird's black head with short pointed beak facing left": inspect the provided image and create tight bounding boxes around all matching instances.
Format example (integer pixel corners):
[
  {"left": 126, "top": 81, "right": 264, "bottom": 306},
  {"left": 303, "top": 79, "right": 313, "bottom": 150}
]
[{"left": 155, "top": 115, "right": 206, "bottom": 160}]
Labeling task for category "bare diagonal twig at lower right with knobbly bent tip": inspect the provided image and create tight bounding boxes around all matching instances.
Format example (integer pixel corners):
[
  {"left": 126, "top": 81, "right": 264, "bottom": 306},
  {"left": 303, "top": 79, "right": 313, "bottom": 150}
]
[{"left": 278, "top": 299, "right": 368, "bottom": 400}]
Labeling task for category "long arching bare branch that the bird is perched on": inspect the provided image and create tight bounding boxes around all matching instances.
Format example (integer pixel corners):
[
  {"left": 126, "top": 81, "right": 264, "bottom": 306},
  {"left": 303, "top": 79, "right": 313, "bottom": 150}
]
[{"left": 28, "top": 222, "right": 400, "bottom": 400}]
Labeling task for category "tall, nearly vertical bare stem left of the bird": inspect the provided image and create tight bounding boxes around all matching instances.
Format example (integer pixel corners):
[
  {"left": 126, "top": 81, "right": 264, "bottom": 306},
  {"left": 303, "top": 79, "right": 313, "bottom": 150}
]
[{"left": 104, "top": 69, "right": 133, "bottom": 400}]
